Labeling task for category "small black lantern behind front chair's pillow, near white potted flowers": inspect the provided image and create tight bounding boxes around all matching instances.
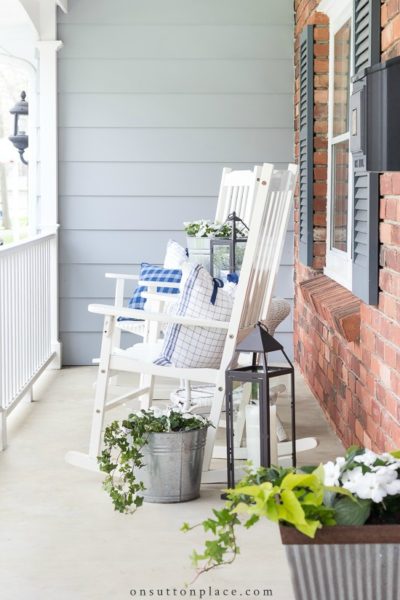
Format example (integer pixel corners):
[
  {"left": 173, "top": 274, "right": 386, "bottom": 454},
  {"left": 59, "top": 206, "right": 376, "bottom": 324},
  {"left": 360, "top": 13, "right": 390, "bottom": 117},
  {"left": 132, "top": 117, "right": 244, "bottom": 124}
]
[{"left": 210, "top": 212, "right": 249, "bottom": 283}]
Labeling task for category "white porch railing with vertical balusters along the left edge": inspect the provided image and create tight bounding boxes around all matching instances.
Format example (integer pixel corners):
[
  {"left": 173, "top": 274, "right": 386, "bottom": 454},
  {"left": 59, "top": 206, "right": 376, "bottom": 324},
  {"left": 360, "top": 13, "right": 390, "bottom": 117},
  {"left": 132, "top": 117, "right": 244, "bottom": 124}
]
[{"left": 0, "top": 233, "right": 59, "bottom": 450}]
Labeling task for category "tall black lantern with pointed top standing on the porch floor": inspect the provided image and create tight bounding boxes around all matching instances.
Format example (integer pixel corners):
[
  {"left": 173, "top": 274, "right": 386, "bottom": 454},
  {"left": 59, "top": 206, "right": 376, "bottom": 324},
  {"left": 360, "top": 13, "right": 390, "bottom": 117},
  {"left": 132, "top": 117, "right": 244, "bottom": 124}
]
[{"left": 225, "top": 322, "right": 296, "bottom": 488}]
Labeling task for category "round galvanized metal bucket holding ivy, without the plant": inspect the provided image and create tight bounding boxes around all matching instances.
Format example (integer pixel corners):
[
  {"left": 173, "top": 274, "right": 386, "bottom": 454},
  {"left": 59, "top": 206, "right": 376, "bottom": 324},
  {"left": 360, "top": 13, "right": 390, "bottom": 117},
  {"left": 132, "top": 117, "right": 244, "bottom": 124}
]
[{"left": 137, "top": 427, "right": 207, "bottom": 503}]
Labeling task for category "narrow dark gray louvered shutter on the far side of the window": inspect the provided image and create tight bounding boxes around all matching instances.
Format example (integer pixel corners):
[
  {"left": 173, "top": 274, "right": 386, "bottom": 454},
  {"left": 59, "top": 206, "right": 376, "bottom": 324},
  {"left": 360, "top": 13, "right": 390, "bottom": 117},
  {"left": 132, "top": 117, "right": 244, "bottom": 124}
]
[{"left": 299, "top": 25, "right": 314, "bottom": 266}]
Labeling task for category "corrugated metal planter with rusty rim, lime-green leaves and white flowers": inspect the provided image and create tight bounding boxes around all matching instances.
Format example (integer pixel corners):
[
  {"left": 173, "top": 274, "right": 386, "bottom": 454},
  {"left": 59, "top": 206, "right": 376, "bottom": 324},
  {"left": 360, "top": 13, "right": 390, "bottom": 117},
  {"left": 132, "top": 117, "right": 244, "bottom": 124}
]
[{"left": 182, "top": 447, "right": 400, "bottom": 600}]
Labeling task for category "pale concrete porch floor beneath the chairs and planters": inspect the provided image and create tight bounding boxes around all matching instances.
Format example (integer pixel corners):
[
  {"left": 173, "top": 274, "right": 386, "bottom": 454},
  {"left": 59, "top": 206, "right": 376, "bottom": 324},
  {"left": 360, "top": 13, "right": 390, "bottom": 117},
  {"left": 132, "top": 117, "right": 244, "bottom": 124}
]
[{"left": 0, "top": 367, "right": 343, "bottom": 600}]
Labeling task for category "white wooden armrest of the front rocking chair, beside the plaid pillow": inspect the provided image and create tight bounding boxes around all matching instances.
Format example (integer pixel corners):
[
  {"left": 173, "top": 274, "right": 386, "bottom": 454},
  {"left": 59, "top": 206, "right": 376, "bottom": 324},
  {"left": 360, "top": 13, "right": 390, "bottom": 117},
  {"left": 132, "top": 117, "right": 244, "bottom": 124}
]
[{"left": 88, "top": 304, "right": 229, "bottom": 330}]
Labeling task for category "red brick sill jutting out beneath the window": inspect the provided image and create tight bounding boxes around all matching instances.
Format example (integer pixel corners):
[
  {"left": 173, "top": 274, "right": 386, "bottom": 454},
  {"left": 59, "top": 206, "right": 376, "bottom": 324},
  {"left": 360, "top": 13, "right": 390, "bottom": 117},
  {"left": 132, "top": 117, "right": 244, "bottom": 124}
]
[{"left": 300, "top": 275, "right": 361, "bottom": 342}]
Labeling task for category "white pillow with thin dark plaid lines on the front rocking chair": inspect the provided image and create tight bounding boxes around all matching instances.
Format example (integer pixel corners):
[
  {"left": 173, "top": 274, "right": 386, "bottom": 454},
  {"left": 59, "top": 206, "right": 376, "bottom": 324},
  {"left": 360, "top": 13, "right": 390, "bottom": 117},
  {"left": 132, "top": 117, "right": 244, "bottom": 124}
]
[{"left": 154, "top": 265, "right": 233, "bottom": 368}]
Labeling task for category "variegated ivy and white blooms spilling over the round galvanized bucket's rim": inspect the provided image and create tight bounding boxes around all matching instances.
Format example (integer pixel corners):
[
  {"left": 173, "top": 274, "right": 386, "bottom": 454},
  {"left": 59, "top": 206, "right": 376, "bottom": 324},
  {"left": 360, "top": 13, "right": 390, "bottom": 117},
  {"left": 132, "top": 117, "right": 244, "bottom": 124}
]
[{"left": 97, "top": 409, "right": 209, "bottom": 513}]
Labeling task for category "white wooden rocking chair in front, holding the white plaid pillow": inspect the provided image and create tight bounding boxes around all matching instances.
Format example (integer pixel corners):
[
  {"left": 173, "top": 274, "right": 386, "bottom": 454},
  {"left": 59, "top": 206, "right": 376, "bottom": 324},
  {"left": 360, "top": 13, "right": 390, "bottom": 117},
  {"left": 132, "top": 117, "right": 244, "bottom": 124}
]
[{"left": 66, "top": 164, "right": 315, "bottom": 482}]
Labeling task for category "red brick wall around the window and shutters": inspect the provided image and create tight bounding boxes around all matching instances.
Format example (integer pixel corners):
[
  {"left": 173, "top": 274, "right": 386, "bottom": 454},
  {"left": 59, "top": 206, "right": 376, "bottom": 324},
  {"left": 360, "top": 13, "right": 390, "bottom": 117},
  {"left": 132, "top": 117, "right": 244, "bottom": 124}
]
[{"left": 294, "top": 0, "right": 400, "bottom": 450}]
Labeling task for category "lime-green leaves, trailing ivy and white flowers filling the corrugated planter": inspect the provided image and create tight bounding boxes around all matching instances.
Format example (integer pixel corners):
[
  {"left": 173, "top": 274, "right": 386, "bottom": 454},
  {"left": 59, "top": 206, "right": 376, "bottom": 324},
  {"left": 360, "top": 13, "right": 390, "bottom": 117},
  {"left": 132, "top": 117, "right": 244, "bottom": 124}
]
[{"left": 183, "top": 446, "right": 400, "bottom": 573}]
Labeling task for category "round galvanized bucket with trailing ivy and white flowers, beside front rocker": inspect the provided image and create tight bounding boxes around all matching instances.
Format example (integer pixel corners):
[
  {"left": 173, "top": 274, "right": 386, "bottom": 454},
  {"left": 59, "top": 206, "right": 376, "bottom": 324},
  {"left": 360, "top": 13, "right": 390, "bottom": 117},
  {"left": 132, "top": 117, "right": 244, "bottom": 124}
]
[{"left": 98, "top": 407, "right": 209, "bottom": 513}]
